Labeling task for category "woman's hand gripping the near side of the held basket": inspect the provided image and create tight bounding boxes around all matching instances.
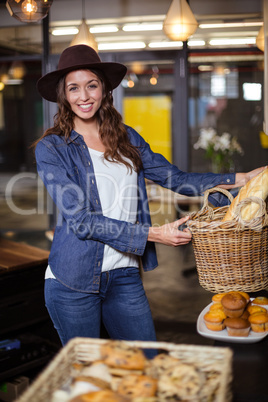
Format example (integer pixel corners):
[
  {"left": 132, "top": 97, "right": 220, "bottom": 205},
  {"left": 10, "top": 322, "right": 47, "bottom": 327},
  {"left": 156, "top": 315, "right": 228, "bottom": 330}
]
[{"left": 148, "top": 216, "right": 192, "bottom": 247}]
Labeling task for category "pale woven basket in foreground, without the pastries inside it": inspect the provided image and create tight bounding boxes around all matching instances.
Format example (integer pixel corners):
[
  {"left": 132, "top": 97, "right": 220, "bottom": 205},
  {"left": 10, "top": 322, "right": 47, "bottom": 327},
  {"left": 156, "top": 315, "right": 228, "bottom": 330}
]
[{"left": 16, "top": 338, "right": 232, "bottom": 402}]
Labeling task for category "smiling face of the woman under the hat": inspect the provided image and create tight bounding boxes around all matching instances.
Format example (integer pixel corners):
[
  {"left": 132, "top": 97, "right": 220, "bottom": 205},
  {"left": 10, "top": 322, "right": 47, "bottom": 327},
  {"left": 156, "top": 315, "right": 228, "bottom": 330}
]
[{"left": 65, "top": 70, "right": 102, "bottom": 123}]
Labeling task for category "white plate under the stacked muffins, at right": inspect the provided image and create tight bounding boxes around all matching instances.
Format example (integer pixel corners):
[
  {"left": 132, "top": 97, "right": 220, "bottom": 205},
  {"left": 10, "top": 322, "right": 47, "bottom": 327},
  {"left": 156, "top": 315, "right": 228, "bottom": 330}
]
[{"left": 196, "top": 298, "right": 268, "bottom": 343}]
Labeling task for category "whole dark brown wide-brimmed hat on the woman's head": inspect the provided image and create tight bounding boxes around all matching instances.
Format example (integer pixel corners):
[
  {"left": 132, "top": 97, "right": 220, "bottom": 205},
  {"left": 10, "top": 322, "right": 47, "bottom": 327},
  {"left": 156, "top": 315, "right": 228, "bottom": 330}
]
[{"left": 37, "top": 45, "right": 127, "bottom": 102}]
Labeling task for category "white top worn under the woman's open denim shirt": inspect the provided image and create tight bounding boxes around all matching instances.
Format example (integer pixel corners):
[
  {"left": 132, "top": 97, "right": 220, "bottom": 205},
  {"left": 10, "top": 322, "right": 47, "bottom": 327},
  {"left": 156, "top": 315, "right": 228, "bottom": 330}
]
[{"left": 45, "top": 148, "right": 139, "bottom": 278}]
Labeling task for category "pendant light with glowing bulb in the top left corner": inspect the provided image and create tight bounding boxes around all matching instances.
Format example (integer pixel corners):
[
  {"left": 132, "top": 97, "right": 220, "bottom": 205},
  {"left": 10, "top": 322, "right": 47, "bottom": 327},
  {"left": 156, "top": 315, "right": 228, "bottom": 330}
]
[{"left": 6, "top": 0, "right": 53, "bottom": 22}]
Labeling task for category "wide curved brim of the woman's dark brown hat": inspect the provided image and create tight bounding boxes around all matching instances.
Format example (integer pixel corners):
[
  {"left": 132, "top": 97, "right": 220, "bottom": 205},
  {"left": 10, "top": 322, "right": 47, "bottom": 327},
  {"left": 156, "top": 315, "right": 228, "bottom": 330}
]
[{"left": 37, "top": 62, "right": 127, "bottom": 102}]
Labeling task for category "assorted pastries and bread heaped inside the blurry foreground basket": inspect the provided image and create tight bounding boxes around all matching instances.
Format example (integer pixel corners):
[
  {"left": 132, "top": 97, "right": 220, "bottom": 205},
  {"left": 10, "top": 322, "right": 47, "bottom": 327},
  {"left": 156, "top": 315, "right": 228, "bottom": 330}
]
[{"left": 46, "top": 340, "right": 228, "bottom": 402}]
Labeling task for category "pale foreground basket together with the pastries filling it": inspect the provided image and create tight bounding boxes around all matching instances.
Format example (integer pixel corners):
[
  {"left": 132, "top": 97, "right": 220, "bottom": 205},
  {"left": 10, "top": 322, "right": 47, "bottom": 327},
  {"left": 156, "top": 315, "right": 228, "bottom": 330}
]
[{"left": 17, "top": 338, "right": 232, "bottom": 402}]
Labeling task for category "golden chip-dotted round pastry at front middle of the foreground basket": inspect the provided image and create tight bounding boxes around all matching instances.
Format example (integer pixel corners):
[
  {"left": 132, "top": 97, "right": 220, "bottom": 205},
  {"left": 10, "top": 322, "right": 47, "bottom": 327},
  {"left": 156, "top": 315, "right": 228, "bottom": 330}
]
[{"left": 117, "top": 374, "right": 157, "bottom": 400}]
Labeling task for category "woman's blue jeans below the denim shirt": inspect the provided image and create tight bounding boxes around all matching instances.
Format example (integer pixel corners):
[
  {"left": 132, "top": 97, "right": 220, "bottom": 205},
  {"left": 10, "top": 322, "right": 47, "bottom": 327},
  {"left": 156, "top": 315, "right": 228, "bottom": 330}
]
[{"left": 45, "top": 267, "right": 156, "bottom": 356}]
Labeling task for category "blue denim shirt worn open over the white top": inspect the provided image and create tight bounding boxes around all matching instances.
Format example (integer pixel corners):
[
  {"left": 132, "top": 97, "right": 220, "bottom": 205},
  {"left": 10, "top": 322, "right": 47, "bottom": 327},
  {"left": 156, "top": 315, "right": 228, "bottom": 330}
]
[{"left": 35, "top": 126, "right": 235, "bottom": 293}]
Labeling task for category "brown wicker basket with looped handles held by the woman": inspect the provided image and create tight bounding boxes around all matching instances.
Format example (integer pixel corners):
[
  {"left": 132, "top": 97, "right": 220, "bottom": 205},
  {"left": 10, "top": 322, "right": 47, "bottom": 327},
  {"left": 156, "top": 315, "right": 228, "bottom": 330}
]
[{"left": 188, "top": 187, "right": 268, "bottom": 293}]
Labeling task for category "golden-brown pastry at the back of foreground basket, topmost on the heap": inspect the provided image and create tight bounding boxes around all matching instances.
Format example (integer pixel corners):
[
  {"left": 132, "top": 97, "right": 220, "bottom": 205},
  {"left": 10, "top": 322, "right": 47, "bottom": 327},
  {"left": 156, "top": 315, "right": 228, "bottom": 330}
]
[{"left": 100, "top": 341, "right": 146, "bottom": 370}]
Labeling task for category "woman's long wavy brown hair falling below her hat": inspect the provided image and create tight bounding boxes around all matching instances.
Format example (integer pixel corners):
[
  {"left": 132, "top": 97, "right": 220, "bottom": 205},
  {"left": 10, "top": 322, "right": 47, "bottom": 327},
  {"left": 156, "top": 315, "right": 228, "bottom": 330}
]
[{"left": 33, "top": 69, "right": 142, "bottom": 172}]
